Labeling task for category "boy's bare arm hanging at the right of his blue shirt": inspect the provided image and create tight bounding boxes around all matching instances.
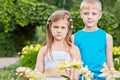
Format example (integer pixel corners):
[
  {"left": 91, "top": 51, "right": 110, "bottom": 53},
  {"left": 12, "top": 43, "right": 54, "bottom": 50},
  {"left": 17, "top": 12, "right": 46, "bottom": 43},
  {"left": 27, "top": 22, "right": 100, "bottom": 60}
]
[{"left": 106, "top": 34, "right": 114, "bottom": 69}]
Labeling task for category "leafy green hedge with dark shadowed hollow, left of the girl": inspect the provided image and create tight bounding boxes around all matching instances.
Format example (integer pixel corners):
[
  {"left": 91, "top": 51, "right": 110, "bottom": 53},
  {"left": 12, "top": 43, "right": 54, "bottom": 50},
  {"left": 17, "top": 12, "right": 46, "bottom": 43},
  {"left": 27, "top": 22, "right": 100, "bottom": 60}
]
[{"left": 0, "top": 0, "right": 57, "bottom": 56}]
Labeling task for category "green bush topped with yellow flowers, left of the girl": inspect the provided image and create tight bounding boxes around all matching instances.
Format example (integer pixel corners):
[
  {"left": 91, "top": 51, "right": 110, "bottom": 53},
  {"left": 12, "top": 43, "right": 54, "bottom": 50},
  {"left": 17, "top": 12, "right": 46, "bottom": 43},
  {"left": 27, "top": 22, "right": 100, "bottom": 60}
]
[{"left": 18, "top": 44, "right": 41, "bottom": 69}]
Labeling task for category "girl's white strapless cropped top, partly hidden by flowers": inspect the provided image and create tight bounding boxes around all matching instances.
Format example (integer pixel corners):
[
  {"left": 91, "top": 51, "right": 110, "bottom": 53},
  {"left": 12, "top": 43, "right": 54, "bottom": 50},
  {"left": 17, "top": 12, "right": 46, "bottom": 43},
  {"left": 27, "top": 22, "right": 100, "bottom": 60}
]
[{"left": 44, "top": 51, "right": 71, "bottom": 70}]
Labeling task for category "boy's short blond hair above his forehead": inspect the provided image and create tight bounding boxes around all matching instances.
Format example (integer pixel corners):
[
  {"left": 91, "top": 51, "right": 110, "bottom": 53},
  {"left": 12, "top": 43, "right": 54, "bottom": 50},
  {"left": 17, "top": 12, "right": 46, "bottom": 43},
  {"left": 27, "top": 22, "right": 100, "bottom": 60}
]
[{"left": 80, "top": 0, "right": 102, "bottom": 11}]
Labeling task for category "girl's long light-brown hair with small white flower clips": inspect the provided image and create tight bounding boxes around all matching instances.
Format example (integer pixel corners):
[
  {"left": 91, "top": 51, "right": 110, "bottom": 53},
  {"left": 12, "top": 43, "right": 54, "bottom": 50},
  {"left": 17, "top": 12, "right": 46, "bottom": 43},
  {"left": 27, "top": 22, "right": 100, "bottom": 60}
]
[{"left": 45, "top": 10, "right": 72, "bottom": 52}]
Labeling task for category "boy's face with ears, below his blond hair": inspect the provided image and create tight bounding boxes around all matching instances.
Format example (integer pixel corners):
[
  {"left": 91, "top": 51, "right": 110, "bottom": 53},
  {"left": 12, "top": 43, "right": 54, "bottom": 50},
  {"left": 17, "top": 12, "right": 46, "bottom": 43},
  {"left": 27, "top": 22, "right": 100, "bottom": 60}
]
[{"left": 80, "top": 7, "right": 102, "bottom": 27}]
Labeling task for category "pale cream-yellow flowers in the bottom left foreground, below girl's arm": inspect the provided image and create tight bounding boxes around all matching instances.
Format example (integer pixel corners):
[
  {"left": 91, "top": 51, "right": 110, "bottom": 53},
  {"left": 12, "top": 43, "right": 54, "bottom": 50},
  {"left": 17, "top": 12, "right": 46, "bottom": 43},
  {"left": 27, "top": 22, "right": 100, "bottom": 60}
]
[{"left": 16, "top": 67, "right": 46, "bottom": 80}]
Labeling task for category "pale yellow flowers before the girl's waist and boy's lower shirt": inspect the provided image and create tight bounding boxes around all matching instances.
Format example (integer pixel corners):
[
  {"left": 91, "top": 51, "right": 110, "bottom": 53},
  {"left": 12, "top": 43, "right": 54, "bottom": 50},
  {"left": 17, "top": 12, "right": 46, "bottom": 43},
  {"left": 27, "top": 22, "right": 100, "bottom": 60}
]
[{"left": 56, "top": 59, "right": 93, "bottom": 80}]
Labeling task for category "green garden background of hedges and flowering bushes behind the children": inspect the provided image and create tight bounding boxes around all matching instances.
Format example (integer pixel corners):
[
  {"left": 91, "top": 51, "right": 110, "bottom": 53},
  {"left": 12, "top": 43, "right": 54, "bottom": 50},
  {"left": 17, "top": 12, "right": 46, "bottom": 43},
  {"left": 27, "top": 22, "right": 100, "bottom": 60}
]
[{"left": 0, "top": 0, "right": 120, "bottom": 80}]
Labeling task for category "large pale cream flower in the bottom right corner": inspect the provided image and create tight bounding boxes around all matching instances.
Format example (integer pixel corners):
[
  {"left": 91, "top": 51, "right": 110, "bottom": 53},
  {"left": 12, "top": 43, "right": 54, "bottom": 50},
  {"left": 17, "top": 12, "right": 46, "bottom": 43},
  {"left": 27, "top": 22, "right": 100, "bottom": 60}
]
[{"left": 99, "top": 63, "right": 120, "bottom": 80}]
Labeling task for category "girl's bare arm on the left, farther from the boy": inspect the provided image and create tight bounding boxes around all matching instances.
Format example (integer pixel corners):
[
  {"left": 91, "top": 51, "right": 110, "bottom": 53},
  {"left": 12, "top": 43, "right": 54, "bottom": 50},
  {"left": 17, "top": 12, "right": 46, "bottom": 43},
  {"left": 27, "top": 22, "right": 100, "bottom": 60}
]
[{"left": 35, "top": 47, "right": 45, "bottom": 73}]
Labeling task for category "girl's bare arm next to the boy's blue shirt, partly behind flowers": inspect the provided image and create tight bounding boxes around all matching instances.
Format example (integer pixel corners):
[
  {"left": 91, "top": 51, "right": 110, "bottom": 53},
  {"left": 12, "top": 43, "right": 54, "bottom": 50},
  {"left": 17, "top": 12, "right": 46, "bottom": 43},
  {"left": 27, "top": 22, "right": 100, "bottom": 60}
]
[{"left": 70, "top": 45, "right": 81, "bottom": 80}]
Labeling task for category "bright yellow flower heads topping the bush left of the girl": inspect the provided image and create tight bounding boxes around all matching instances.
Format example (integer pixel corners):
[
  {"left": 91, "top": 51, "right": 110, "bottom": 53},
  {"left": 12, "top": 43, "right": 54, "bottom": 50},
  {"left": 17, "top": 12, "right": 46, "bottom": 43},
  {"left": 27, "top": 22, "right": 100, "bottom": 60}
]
[{"left": 18, "top": 44, "right": 41, "bottom": 57}]
